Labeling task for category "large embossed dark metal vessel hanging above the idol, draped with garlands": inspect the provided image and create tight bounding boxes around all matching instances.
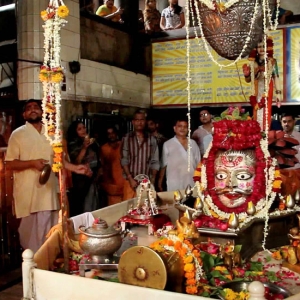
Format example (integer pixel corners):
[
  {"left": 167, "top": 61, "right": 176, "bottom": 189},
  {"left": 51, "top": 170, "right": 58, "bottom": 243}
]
[{"left": 198, "top": 0, "right": 274, "bottom": 60}]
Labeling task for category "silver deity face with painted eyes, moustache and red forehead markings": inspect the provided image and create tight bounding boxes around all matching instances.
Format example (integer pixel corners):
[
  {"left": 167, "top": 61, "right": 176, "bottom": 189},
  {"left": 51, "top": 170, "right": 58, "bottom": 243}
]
[{"left": 214, "top": 150, "right": 255, "bottom": 208}]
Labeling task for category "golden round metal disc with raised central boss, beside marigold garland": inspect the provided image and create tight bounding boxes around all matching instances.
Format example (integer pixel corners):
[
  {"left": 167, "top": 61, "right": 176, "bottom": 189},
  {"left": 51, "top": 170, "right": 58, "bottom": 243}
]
[{"left": 118, "top": 246, "right": 167, "bottom": 290}]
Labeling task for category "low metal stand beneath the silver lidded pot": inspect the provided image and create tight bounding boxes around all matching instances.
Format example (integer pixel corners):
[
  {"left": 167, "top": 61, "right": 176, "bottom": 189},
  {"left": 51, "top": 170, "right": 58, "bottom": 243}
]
[{"left": 79, "top": 256, "right": 120, "bottom": 278}]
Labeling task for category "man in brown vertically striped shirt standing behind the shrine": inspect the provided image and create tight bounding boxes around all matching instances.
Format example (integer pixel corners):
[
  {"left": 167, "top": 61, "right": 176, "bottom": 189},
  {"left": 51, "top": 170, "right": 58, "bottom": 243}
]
[{"left": 121, "top": 110, "right": 159, "bottom": 200}]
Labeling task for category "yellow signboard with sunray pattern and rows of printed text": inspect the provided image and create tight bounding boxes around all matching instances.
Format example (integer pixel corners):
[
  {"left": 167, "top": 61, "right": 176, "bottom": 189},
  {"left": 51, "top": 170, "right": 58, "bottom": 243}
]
[{"left": 152, "top": 30, "right": 284, "bottom": 106}]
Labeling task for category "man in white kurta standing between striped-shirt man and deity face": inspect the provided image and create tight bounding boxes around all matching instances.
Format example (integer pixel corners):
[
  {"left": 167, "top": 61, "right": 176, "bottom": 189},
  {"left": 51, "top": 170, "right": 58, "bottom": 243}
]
[{"left": 158, "top": 120, "right": 200, "bottom": 191}]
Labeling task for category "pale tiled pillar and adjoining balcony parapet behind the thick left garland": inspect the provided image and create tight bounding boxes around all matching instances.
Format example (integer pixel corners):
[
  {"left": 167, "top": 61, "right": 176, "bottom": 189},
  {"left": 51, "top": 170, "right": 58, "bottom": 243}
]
[{"left": 18, "top": 0, "right": 150, "bottom": 111}]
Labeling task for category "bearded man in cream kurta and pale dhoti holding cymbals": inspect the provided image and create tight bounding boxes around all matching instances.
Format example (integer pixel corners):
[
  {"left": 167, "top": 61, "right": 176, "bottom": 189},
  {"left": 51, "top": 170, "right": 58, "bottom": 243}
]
[{"left": 5, "top": 100, "right": 59, "bottom": 251}]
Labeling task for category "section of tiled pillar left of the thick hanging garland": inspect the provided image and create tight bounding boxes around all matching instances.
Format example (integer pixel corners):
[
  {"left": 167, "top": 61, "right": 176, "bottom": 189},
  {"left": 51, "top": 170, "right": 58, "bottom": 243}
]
[{"left": 17, "top": 0, "right": 48, "bottom": 100}]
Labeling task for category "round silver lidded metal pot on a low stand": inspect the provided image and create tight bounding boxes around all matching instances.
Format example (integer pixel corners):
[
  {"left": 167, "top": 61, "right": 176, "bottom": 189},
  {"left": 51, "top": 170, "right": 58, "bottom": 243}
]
[{"left": 78, "top": 220, "right": 122, "bottom": 263}]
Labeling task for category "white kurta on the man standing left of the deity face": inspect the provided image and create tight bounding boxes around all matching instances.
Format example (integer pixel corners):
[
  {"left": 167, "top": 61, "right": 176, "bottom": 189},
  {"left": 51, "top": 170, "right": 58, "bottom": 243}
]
[{"left": 161, "top": 136, "right": 200, "bottom": 191}]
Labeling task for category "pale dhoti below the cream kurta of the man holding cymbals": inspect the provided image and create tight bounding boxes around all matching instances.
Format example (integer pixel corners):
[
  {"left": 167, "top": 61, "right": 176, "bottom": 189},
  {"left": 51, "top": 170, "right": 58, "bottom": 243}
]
[{"left": 18, "top": 211, "right": 58, "bottom": 252}]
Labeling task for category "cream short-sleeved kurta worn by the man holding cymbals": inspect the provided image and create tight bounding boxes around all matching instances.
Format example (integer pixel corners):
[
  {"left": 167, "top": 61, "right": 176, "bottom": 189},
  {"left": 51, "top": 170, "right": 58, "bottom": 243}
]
[{"left": 5, "top": 122, "right": 59, "bottom": 218}]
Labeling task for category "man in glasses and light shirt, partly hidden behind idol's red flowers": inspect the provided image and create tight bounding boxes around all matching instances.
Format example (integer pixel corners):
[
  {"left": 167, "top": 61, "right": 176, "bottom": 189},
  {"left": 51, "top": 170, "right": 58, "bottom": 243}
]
[{"left": 192, "top": 106, "right": 213, "bottom": 157}]
